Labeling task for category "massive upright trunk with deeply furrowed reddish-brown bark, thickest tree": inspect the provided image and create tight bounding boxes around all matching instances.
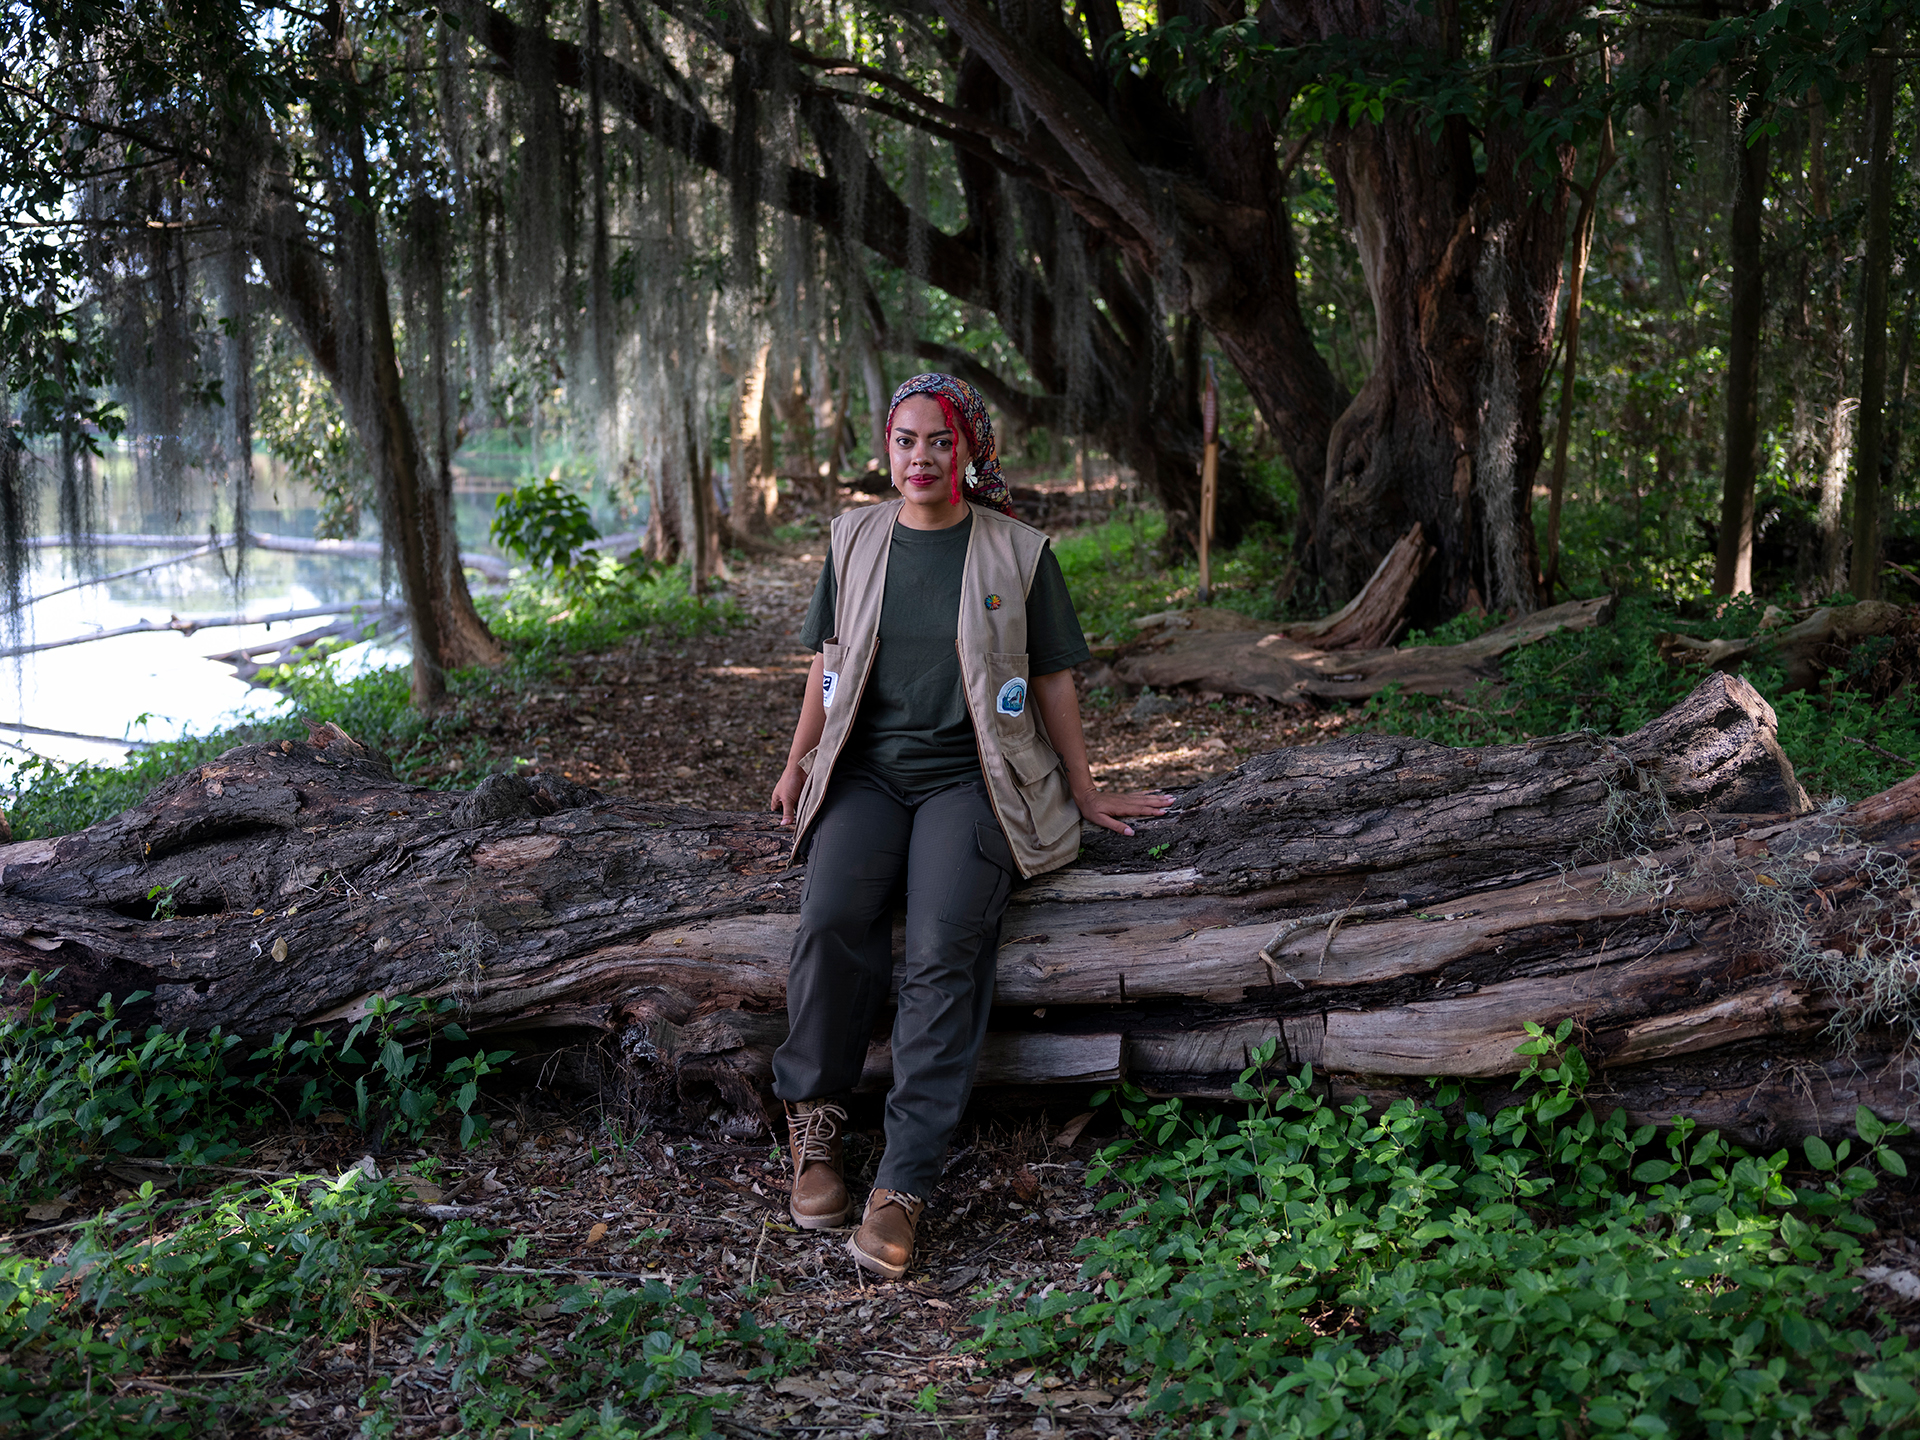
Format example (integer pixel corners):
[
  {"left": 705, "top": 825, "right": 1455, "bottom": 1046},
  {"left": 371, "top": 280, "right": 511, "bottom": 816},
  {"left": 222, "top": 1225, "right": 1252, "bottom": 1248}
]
[{"left": 1315, "top": 0, "right": 1571, "bottom": 618}]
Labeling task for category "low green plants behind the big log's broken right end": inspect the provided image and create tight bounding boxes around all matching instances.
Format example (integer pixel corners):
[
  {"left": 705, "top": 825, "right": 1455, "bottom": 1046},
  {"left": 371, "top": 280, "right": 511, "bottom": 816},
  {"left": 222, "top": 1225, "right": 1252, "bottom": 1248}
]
[{"left": 1361, "top": 597, "right": 1920, "bottom": 797}]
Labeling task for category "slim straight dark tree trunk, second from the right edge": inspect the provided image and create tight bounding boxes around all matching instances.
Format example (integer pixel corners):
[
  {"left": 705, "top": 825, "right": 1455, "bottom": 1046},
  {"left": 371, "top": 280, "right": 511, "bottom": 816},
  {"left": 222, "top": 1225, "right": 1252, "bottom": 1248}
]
[{"left": 1713, "top": 104, "right": 1770, "bottom": 595}]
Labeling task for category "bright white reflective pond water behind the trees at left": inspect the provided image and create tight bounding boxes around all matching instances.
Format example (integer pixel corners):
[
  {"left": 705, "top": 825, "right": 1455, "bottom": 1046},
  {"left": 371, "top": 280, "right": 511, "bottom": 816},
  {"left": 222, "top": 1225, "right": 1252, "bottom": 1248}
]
[{"left": 0, "top": 444, "right": 643, "bottom": 779}]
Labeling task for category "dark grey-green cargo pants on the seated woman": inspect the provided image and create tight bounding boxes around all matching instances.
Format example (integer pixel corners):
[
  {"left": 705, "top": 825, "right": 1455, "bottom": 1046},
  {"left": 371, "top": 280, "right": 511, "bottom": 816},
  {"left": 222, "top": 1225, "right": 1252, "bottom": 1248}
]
[{"left": 774, "top": 772, "right": 1014, "bottom": 1198}]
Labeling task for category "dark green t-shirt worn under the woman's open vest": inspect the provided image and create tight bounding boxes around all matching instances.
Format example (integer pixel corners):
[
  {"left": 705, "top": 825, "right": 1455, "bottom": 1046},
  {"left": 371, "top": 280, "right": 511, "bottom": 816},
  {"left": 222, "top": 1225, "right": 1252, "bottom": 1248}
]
[{"left": 801, "top": 515, "right": 1092, "bottom": 795}]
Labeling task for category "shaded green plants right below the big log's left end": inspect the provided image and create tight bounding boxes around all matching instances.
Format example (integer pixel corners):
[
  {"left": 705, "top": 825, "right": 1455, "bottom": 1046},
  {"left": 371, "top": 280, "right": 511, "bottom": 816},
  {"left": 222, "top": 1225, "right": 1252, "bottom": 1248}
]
[{"left": 0, "top": 972, "right": 507, "bottom": 1198}]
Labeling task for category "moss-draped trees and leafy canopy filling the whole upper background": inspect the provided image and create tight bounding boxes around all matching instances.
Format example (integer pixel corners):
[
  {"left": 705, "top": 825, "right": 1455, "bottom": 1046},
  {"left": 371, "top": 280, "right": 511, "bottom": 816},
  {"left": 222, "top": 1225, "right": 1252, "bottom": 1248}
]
[{"left": 0, "top": 0, "right": 1912, "bottom": 705}]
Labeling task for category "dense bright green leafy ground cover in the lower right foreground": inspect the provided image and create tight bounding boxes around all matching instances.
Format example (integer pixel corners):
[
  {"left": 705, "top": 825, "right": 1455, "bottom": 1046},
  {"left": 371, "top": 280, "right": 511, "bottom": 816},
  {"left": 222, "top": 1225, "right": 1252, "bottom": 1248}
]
[{"left": 977, "top": 1044, "right": 1920, "bottom": 1440}]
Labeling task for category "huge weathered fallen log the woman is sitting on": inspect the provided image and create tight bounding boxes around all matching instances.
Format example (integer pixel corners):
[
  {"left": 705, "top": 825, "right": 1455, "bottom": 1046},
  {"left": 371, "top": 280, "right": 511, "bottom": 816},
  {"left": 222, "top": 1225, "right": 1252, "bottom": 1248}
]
[{"left": 0, "top": 674, "right": 1920, "bottom": 1142}]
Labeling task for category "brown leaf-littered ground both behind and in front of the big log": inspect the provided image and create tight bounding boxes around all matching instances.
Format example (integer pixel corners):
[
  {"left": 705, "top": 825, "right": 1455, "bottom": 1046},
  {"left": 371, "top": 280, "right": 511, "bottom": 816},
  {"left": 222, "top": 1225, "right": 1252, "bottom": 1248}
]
[{"left": 15, "top": 526, "right": 1920, "bottom": 1440}]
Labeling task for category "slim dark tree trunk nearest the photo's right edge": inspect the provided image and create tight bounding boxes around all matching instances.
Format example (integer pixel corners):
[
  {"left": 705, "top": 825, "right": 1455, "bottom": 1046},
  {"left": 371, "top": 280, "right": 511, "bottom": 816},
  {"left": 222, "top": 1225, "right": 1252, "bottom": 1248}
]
[{"left": 1851, "top": 25, "right": 1899, "bottom": 599}]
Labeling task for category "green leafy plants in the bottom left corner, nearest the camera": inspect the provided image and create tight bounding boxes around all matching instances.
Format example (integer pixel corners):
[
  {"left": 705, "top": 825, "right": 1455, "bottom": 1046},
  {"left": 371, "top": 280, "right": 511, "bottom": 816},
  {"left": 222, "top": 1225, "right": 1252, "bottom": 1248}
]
[{"left": 0, "top": 1169, "right": 804, "bottom": 1440}]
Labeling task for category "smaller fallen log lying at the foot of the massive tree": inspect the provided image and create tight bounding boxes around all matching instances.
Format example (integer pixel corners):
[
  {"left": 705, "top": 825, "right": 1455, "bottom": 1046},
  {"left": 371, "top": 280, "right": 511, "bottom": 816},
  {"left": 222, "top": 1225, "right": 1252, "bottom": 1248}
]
[{"left": 1114, "top": 595, "right": 1613, "bottom": 705}]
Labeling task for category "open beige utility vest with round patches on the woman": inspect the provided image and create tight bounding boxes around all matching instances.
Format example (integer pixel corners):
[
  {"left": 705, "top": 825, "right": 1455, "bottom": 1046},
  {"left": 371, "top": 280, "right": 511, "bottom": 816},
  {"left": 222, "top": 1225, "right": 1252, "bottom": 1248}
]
[{"left": 793, "top": 499, "right": 1079, "bottom": 876}]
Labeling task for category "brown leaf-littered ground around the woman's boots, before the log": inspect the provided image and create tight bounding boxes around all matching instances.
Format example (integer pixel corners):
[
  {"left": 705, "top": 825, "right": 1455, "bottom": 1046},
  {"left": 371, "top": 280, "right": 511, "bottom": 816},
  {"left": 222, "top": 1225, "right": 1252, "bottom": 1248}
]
[{"left": 22, "top": 1092, "right": 1154, "bottom": 1440}]
